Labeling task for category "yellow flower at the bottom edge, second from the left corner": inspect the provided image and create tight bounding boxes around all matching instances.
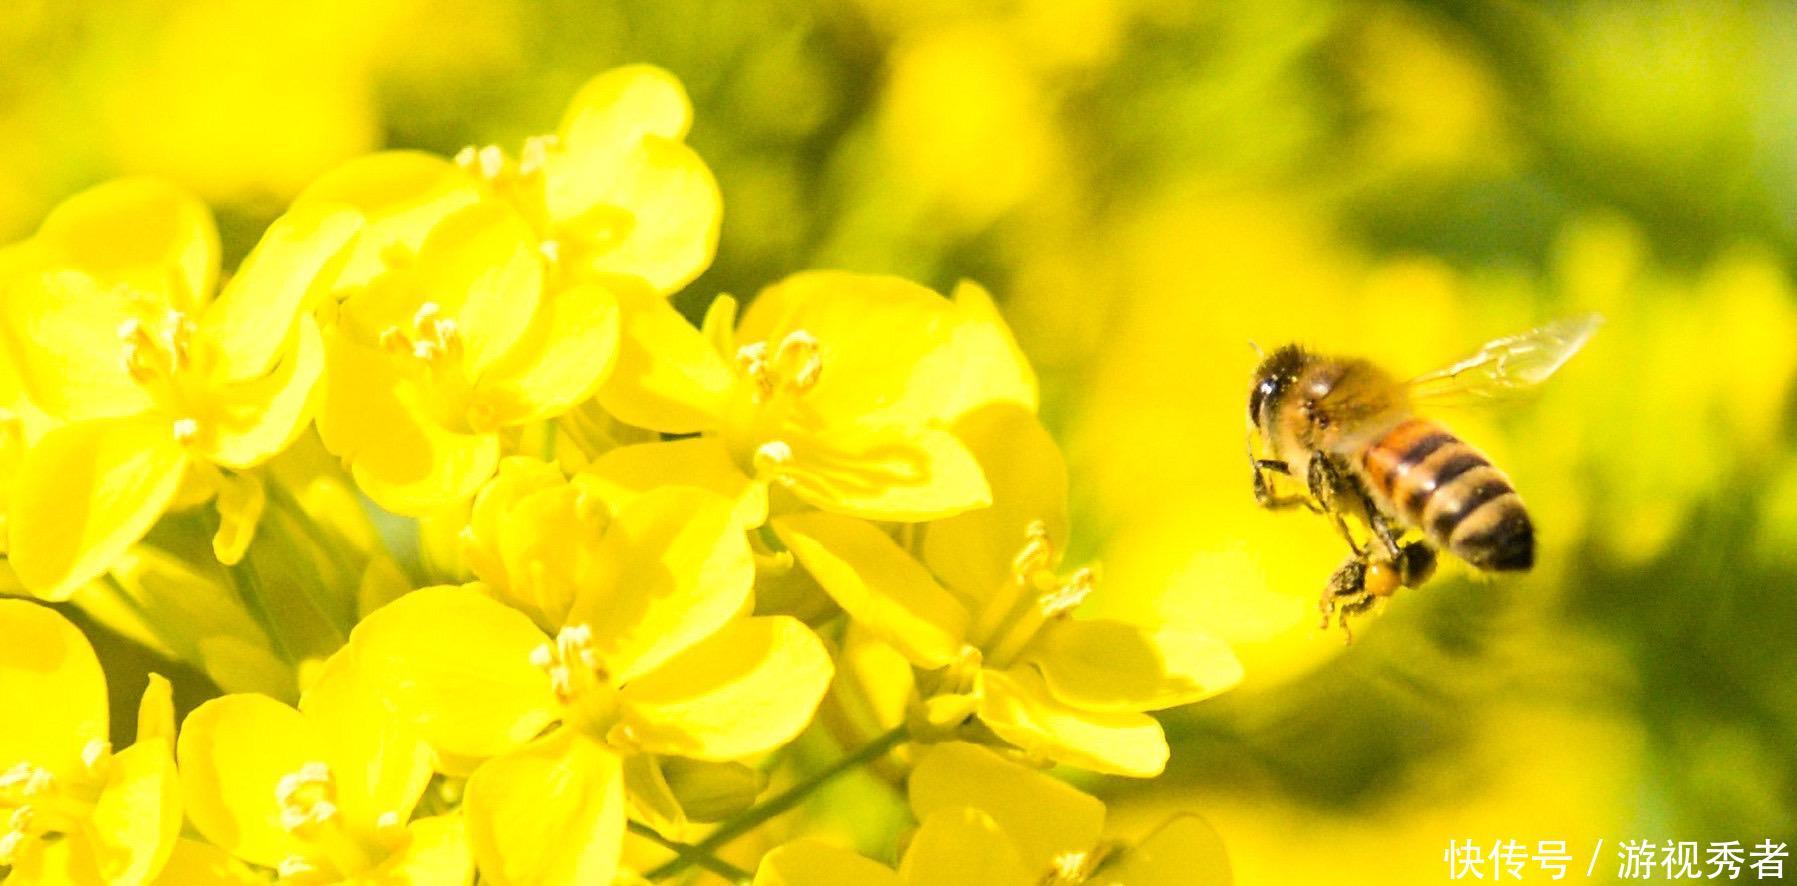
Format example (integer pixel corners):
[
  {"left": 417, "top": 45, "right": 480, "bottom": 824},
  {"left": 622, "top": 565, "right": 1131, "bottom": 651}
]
[{"left": 178, "top": 652, "right": 473, "bottom": 884}]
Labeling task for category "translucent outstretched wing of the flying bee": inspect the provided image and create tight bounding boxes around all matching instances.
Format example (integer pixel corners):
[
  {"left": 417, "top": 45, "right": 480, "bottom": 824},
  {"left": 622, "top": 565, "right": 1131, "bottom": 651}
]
[{"left": 1405, "top": 315, "right": 1603, "bottom": 404}]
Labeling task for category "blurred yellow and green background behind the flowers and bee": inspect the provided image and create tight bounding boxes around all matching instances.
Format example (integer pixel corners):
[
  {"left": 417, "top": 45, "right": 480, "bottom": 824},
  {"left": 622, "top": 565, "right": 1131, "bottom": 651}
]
[{"left": 0, "top": 0, "right": 1797, "bottom": 884}]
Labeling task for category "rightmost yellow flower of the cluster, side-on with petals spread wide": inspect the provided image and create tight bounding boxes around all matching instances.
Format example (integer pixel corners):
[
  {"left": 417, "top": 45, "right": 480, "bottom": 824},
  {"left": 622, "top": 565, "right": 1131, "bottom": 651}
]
[{"left": 773, "top": 406, "right": 1242, "bottom": 776}]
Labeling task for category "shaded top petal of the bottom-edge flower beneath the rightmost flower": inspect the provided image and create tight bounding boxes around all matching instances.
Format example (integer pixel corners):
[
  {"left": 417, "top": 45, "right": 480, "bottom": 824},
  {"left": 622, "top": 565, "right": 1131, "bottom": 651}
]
[{"left": 906, "top": 742, "right": 1105, "bottom": 870}]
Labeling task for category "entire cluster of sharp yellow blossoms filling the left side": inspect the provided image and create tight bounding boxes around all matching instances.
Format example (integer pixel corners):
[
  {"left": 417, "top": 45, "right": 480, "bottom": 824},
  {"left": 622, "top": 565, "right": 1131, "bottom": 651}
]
[{"left": 0, "top": 66, "right": 1240, "bottom": 884}]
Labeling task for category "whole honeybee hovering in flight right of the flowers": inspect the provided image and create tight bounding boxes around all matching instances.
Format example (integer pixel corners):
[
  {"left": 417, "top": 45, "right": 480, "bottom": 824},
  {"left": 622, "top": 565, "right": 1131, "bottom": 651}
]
[{"left": 1247, "top": 315, "right": 1603, "bottom": 642}]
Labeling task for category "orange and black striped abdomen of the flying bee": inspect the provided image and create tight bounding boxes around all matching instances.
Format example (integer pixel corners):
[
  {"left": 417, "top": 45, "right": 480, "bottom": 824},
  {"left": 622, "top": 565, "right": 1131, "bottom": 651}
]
[{"left": 1362, "top": 419, "right": 1535, "bottom": 570}]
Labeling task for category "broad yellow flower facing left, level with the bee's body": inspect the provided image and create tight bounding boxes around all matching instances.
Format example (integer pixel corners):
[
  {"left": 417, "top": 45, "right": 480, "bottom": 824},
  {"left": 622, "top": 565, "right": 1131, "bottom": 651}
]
[{"left": 589, "top": 271, "right": 1035, "bottom": 525}]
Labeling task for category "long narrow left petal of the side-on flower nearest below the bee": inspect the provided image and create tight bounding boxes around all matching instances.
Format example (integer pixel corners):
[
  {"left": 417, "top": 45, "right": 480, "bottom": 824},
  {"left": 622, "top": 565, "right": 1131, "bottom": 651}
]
[{"left": 773, "top": 512, "right": 967, "bottom": 669}]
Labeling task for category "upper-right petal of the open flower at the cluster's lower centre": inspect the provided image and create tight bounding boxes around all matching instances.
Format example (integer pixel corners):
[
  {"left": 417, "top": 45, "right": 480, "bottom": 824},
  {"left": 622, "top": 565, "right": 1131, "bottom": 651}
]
[{"left": 568, "top": 487, "right": 755, "bottom": 685}]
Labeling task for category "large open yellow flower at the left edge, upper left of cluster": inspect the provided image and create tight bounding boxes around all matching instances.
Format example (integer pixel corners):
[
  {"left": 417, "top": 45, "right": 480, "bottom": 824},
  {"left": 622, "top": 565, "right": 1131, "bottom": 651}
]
[{"left": 0, "top": 180, "right": 358, "bottom": 598}]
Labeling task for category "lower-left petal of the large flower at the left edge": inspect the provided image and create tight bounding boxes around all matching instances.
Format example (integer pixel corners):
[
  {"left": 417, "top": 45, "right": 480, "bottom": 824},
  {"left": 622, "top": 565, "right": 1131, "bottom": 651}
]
[{"left": 9, "top": 415, "right": 187, "bottom": 600}]
